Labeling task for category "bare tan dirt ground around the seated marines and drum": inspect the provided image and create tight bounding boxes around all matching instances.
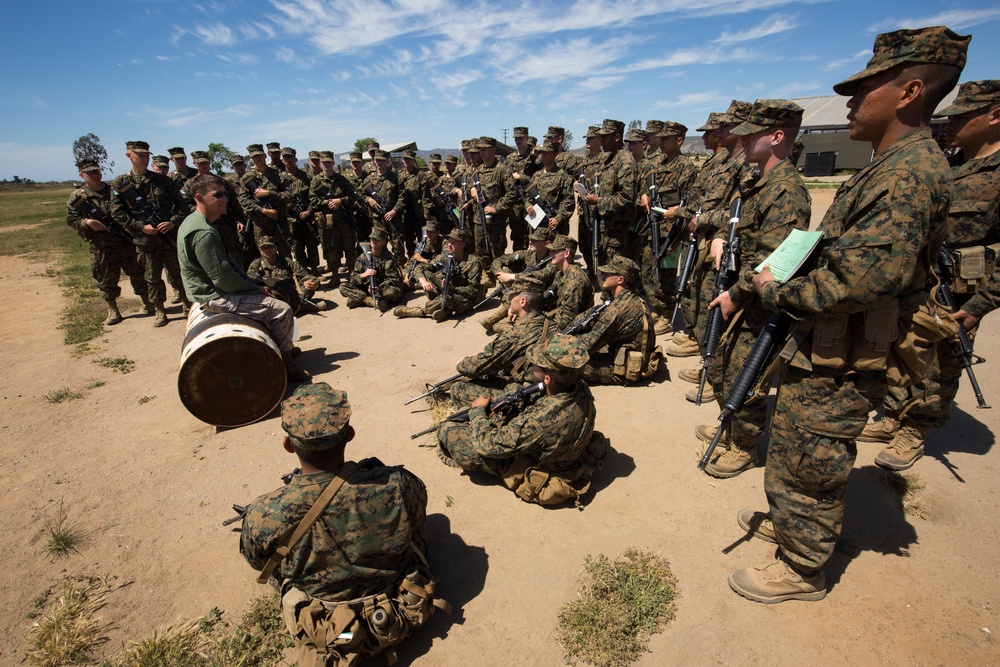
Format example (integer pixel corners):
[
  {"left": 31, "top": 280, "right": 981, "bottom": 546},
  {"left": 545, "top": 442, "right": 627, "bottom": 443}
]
[{"left": 0, "top": 189, "right": 1000, "bottom": 666}]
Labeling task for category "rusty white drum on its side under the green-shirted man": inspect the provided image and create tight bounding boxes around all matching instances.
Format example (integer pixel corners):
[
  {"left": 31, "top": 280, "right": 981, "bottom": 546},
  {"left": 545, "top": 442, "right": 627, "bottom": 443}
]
[{"left": 177, "top": 304, "right": 287, "bottom": 426}]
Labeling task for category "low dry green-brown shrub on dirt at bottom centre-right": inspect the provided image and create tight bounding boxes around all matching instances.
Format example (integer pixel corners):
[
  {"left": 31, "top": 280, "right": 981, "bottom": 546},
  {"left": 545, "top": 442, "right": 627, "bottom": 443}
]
[{"left": 556, "top": 549, "right": 677, "bottom": 667}]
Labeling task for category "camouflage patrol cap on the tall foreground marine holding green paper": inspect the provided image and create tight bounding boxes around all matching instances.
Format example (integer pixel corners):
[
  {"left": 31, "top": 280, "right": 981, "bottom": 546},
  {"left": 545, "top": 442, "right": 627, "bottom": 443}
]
[{"left": 833, "top": 26, "right": 972, "bottom": 95}]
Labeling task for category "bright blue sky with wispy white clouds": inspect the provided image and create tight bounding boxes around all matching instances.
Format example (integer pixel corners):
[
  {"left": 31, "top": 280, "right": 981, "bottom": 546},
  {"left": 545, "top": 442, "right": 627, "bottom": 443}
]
[{"left": 0, "top": 0, "right": 1000, "bottom": 181}]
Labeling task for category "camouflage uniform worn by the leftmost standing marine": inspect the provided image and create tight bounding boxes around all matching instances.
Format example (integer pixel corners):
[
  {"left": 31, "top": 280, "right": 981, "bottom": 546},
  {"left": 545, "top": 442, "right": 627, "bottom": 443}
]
[{"left": 66, "top": 180, "right": 149, "bottom": 308}]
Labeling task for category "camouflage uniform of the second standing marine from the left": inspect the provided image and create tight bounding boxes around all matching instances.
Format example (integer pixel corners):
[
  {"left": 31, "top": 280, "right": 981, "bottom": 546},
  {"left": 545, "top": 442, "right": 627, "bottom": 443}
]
[{"left": 111, "top": 164, "right": 188, "bottom": 309}]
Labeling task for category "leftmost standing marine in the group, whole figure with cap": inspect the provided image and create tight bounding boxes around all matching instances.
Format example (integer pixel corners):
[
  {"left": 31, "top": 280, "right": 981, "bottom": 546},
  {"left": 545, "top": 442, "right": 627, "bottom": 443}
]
[{"left": 66, "top": 160, "right": 147, "bottom": 326}]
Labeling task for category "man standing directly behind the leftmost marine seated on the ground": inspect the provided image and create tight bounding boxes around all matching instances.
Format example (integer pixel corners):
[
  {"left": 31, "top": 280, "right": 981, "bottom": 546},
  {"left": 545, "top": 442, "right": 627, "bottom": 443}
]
[{"left": 238, "top": 144, "right": 292, "bottom": 257}]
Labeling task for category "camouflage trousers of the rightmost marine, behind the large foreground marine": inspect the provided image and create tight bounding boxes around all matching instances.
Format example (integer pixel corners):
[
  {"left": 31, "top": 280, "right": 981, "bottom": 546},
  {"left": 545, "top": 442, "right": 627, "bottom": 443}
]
[{"left": 885, "top": 327, "right": 978, "bottom": 430}]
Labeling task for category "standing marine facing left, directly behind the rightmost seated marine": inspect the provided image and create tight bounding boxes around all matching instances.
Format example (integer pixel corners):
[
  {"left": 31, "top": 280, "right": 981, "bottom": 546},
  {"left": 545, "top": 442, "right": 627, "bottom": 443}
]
[{"left": 587, "top": 118, "right": 638, "bottom": 261}]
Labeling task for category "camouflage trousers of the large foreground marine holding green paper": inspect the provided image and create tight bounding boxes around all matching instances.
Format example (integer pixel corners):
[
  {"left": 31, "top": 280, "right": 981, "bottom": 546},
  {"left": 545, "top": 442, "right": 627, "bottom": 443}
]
[{"left": 764, "top": 368, "right": 885, "bottom": 572}]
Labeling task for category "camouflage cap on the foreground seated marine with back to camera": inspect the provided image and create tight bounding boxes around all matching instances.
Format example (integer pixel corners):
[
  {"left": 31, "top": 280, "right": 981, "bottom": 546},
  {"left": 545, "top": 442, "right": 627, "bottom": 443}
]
[{"left": 281, "top": 382, "right": 351, "bottom": 452}]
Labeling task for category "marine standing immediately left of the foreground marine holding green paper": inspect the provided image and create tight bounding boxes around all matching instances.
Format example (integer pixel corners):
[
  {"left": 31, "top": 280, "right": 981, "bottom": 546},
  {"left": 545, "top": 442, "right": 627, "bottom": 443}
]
[{"left": 699, "top": 100, "right": 812, "bottom": 478}]
